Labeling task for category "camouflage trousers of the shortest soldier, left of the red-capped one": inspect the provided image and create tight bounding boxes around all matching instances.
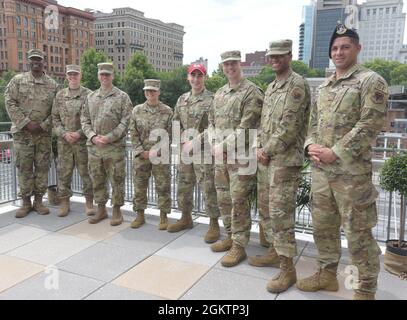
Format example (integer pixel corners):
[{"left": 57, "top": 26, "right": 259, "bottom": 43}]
[{"left": 133, "top": 156, "right": 171, "bottom": 213}]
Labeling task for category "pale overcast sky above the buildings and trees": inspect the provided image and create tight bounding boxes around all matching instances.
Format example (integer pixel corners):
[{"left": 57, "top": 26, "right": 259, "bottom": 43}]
[{"left": 58, "top": 0, "right": 407, "bottom": 72}]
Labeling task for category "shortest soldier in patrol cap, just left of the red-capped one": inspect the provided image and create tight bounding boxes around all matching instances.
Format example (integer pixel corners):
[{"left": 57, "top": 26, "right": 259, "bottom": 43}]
[{"left": 130, "top": 79, "right": 172, "bottom": 230}]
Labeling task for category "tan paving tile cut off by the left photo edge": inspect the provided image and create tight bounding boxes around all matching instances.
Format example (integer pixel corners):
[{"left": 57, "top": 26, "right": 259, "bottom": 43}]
[{"left": 0, "top": 255, "right": 44, "bottom": 299}]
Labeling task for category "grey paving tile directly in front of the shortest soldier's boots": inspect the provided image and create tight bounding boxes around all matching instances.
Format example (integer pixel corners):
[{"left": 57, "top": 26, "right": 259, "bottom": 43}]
[{"left": 105, "top": 222, "right": 185, "bottom": 254}]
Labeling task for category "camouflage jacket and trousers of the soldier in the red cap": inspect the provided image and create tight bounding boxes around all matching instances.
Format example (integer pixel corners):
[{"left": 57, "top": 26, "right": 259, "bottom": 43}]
[{"left": 173, "top": 89, "right": 220, "bottom": 218}]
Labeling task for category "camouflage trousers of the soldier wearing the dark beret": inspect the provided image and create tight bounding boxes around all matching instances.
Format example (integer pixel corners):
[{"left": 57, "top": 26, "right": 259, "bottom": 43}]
[{"left": 312, "top": 168, "right": 381, "bottom": 293}]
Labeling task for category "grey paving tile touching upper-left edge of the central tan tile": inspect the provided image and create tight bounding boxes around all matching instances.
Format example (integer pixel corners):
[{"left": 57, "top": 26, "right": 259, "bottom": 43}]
[{"left": 57, "top": 242, "right": 149, "bottom": 282}]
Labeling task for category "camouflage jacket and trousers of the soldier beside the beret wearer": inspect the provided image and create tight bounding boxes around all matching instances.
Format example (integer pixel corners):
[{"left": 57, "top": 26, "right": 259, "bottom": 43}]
[{"left": 257, "top": 71, "right": 310, "bottom": 258}]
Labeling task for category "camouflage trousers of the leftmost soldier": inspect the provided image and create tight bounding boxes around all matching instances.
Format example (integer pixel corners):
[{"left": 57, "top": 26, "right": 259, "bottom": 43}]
[{"left": 13, "top": 132, "right": 51, "bottom": 197}]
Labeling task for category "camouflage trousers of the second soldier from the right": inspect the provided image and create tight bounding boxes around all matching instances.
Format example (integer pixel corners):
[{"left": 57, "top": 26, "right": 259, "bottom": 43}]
[{"left": 257, "top": 163, "right": 301, "bottom": 258}]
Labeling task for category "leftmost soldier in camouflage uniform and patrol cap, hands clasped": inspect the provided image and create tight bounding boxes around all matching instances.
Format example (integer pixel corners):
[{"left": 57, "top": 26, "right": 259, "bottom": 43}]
[{"left": 5, "top": 49, "right": 58, "bottom": 218}]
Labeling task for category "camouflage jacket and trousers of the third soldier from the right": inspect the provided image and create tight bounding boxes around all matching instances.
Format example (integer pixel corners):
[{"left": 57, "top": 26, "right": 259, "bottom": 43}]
[{"left": 209, "top": 79, "right": 263, "bottom": 247}]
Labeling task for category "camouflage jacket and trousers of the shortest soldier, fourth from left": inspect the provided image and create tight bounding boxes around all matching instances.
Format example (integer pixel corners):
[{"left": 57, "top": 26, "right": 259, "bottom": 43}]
[{"left": 130, "top": 102, "right": 172, "bottom": 213}]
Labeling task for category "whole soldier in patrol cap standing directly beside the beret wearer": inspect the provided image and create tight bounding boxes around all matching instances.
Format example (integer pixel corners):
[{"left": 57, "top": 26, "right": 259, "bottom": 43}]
[{"left": 249, "top": 40, "right": 311, "bottom": 293}]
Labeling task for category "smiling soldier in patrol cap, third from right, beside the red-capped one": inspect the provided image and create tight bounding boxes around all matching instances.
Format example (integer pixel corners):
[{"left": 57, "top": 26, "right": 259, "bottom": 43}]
[{"left": 208, "top": 51, "right": 263, "bottom": 267}]
